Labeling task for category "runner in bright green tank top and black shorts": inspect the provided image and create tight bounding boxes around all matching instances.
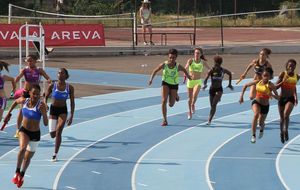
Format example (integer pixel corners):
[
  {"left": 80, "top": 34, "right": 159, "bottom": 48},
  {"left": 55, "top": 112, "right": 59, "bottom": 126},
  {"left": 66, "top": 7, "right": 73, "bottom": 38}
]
[{"left": 148, "top": 49, "right": 190, "bottom": 126}]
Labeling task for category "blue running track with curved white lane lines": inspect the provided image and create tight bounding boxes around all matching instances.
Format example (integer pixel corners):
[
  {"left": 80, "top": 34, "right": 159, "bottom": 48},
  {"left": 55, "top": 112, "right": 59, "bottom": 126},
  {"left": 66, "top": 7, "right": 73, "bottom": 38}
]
[{"left": 0, "top": 67, "right": 300, "bottom": 190}]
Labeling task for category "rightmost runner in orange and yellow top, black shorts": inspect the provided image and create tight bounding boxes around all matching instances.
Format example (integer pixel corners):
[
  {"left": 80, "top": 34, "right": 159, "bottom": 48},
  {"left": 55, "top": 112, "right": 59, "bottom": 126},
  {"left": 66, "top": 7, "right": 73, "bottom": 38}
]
[{"left": 276, "top": 59, "right": 300, "bottom": 143}]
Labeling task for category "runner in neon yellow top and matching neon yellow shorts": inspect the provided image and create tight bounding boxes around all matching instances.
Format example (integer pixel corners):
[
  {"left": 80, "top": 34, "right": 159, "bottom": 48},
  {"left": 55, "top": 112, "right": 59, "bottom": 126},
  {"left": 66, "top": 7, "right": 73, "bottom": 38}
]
[{"left": 185, "top": 48, "right": 210, "bottom": 119}]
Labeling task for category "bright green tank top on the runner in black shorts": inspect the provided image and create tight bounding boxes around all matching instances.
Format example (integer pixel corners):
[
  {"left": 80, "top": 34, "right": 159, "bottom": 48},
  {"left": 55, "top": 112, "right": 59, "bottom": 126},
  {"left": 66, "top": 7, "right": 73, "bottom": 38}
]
[{"left": 162, "top": 61, "right": 179, "bottom": 85}]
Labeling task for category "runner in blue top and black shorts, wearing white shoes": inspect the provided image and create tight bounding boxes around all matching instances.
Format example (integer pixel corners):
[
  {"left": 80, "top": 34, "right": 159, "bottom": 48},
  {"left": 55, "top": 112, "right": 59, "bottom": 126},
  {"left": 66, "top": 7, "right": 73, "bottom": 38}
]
[{"left": 45, "top": 68, "right": 75, "bottom": 162}]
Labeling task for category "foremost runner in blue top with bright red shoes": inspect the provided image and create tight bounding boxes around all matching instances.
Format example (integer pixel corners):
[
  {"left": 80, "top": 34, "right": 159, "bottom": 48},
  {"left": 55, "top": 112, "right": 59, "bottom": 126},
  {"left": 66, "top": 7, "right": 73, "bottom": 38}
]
[{"left": 5, "top": 84, "right": 48, "bottom": 188}]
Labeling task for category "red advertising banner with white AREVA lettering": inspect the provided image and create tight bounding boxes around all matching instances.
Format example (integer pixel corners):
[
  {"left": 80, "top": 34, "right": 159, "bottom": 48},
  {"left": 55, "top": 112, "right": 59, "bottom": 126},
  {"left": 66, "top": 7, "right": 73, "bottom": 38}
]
[{"left": 0, "top": 24, "right": 105, "bottom": 47}]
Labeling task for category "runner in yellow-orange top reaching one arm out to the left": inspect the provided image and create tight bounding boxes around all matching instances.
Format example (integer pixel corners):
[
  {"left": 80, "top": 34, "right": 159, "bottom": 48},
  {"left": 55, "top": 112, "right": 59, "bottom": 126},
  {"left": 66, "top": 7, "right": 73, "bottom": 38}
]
[{"left": 239, "top": 67, "right": 279, "bottom": 143}]
